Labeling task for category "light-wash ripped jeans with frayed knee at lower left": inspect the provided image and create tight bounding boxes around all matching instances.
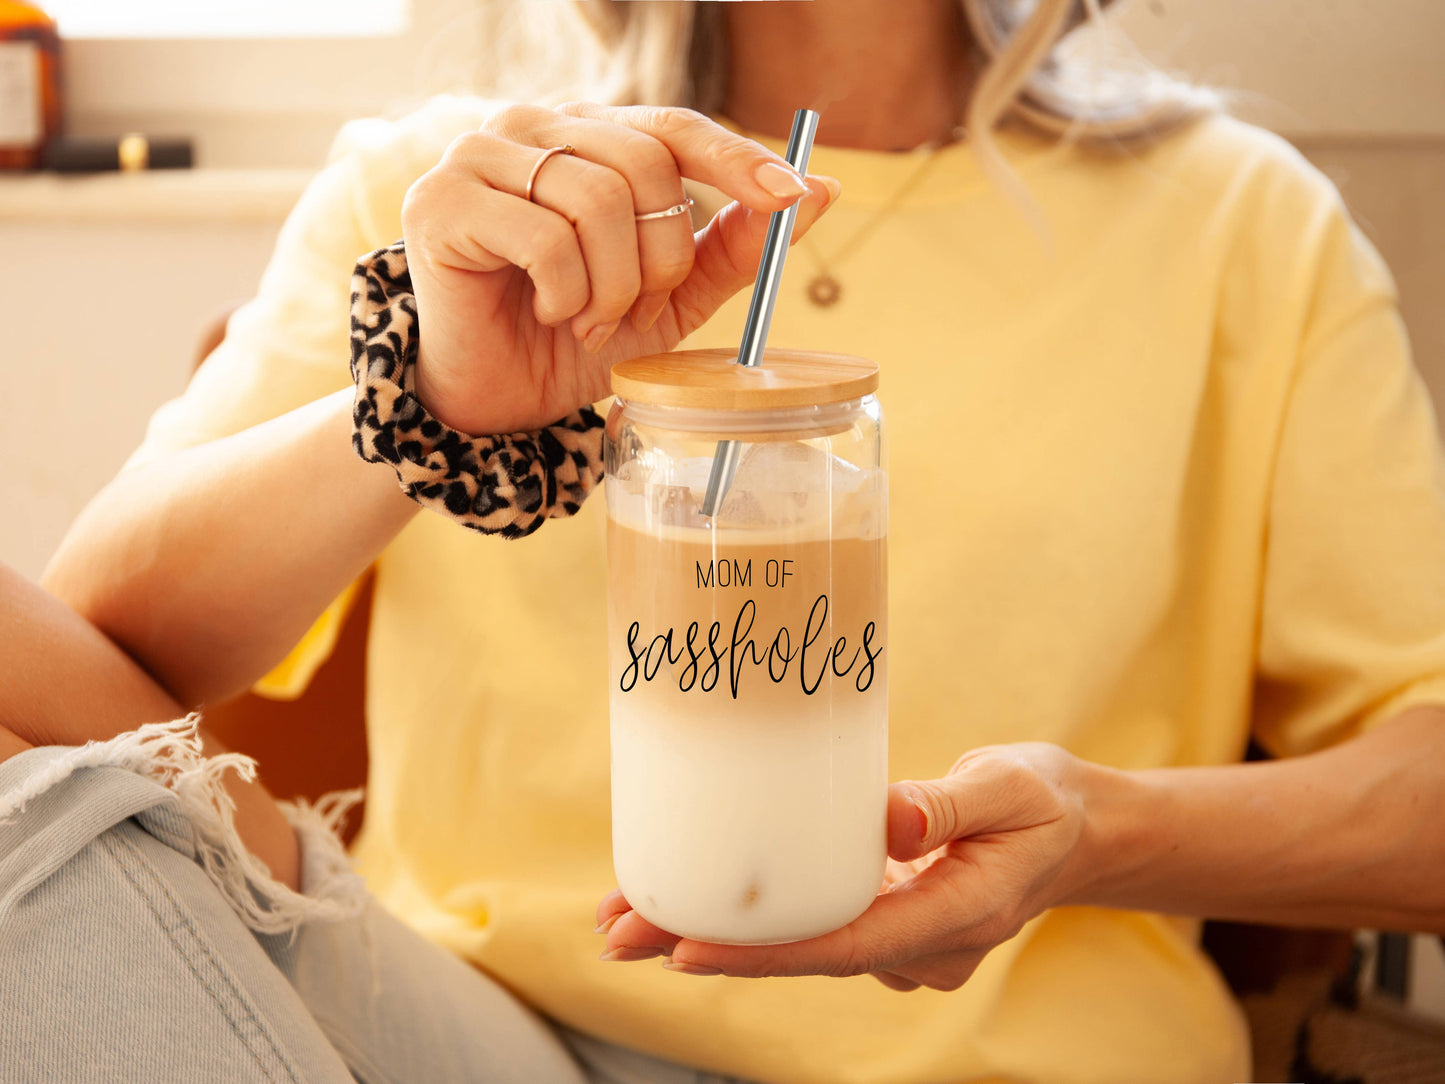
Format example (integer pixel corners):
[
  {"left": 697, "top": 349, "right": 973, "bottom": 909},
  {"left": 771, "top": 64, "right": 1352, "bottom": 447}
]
[{"left": 0, "top": 720, "right": 757, "bottom": 1084}]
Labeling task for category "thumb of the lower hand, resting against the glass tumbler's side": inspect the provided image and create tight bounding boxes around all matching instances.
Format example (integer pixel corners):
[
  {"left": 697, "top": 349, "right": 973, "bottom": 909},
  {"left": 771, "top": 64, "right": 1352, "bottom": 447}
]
[{"left": 889, "top": 757, "right": 1038, "bottom": 861}]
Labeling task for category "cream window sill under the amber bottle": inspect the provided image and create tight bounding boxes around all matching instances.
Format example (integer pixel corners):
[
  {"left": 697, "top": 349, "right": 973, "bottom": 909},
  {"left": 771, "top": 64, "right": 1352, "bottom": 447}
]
[{"left": 0, "top": 169, "right": 314, "bottom": 225}]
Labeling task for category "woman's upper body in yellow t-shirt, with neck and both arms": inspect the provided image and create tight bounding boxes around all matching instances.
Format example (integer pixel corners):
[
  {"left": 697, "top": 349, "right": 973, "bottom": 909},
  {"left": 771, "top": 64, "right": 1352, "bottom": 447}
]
[{"left": 39, "top": 0, "right": 1445, "bottom": 1083}]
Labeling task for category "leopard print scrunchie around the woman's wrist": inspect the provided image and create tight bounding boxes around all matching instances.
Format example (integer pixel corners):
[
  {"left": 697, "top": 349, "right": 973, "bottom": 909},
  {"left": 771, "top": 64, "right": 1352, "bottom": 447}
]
[{"left": 351, "top": 241, "right": 603, "bottom": 538}]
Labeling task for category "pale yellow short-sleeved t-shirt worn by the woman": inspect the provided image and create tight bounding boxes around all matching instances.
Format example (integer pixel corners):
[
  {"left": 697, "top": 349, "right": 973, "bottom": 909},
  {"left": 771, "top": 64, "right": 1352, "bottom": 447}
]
[{"left": 127, "top": 100, "right": 1445, "bottom": 1084}]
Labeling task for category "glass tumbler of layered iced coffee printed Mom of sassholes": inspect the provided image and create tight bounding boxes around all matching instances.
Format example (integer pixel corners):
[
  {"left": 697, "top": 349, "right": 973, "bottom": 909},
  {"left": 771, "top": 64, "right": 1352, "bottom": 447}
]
[{"left": 605, "top": 350, "right": 887, "bottom": 944}]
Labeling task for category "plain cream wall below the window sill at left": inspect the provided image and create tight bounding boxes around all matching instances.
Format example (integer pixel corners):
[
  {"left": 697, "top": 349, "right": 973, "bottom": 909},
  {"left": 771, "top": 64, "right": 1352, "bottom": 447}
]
[{"left": 0, "top": 186, "right": 296, "bottom": 577}]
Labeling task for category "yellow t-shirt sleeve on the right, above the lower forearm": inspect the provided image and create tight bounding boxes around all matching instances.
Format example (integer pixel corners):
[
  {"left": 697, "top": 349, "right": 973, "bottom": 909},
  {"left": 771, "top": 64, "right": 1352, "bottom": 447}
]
[{"left": 1254, "top": 207, "right": 1445, "bottom": 756}]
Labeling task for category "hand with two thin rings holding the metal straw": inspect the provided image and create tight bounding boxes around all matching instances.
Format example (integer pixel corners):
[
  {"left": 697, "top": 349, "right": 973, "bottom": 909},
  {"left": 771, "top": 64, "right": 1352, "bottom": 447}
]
[{"left": 402, "top": 103, "right": 840, "bottom": 436}]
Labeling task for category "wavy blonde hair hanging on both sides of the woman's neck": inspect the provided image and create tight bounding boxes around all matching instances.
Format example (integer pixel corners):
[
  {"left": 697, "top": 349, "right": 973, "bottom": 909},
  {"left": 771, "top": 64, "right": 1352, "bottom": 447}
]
[{"left": 453, "top": 0, "right": 1220, "bottom": 175}]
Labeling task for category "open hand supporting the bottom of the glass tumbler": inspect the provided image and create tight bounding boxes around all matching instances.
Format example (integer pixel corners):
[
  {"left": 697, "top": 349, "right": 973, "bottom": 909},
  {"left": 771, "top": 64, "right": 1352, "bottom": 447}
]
[{"left": 597, "top": 743, "right": 1094, "bottom": 990}]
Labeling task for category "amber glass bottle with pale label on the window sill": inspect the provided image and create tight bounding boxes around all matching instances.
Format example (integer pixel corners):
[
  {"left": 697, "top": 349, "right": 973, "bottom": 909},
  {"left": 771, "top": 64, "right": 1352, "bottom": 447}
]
[{"left": 0, "top": 0, "right": 61, "bottom": 169}]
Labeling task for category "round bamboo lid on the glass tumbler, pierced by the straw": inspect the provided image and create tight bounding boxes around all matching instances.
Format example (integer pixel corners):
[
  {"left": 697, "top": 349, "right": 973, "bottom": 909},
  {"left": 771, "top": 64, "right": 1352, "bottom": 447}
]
[{"left": 613, "top": 348, "right": 879, "bottom": 410}]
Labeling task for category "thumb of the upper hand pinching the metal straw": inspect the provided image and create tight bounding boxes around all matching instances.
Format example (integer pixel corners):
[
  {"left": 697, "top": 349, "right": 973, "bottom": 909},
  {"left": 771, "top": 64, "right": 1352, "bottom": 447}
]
[{"left": 670, "top": 175, "right": 842, "bottom": 338}]
